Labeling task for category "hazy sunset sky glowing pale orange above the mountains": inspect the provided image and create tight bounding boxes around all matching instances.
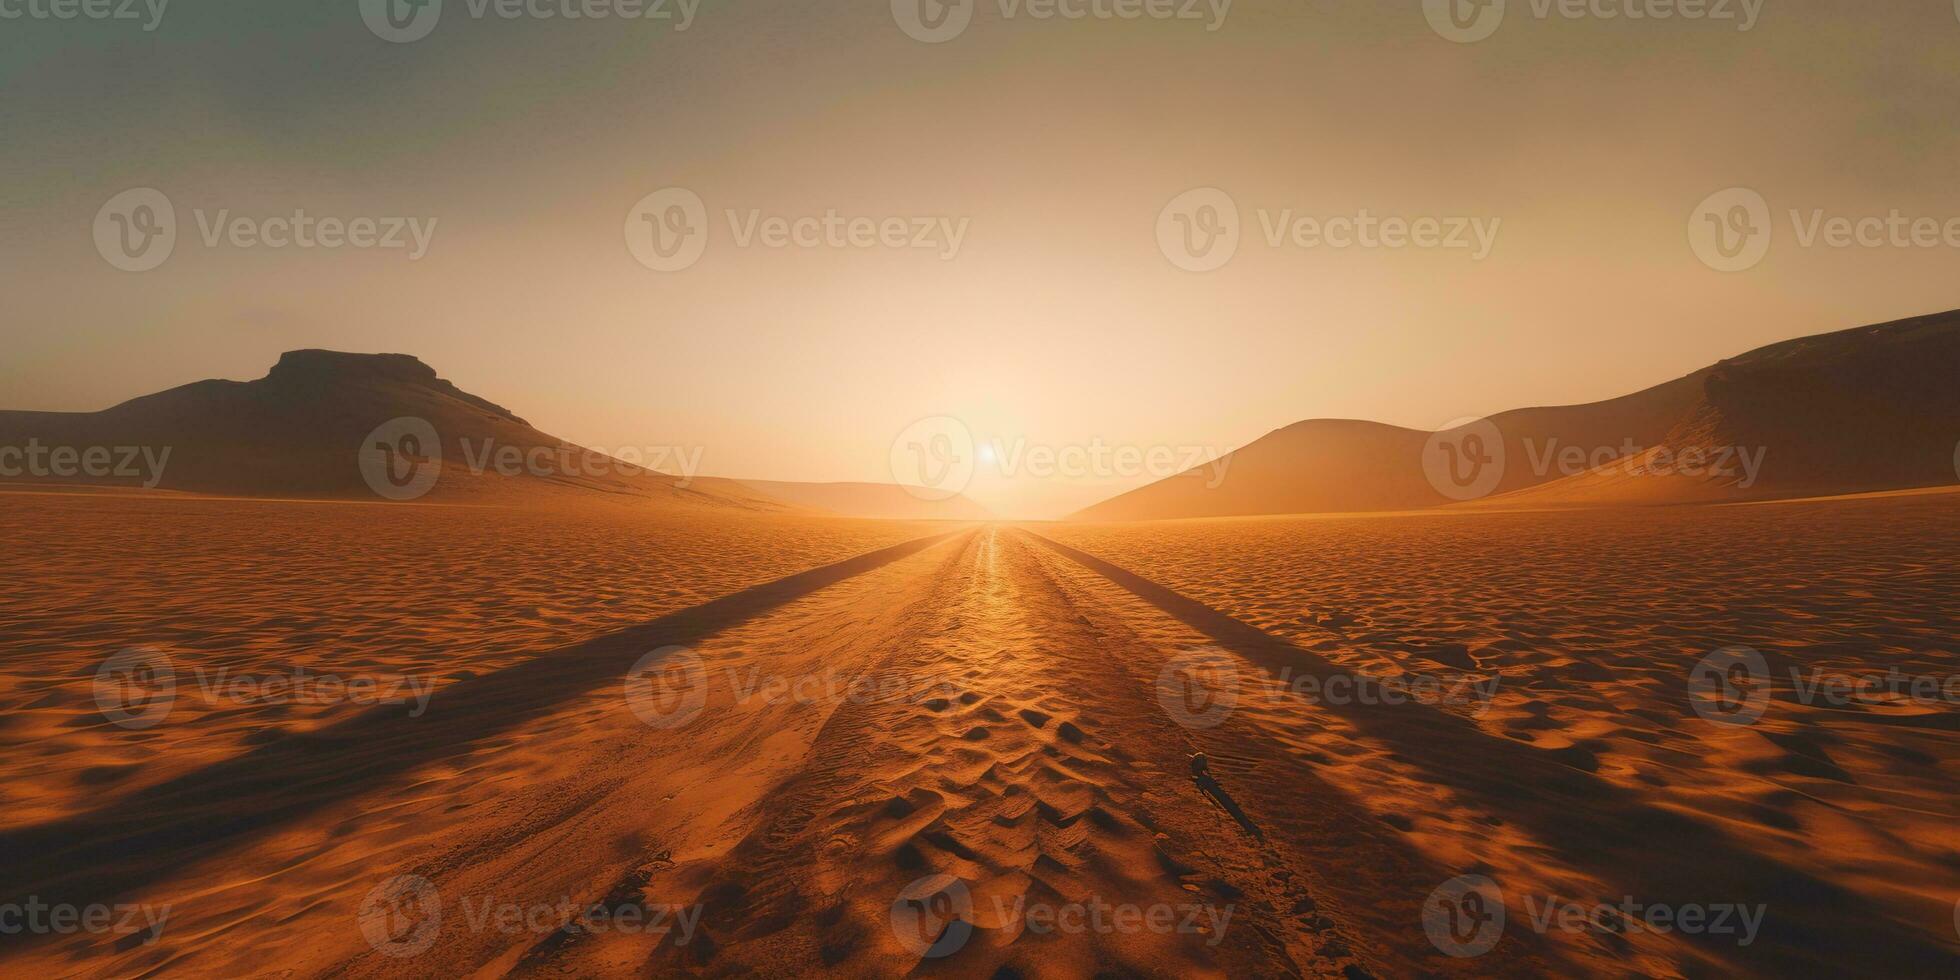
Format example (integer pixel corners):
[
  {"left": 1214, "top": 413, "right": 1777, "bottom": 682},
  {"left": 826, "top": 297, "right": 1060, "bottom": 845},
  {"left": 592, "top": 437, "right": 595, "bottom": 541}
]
[{"left": 0, "top": 0, "right": 1960, "bottom": 517}]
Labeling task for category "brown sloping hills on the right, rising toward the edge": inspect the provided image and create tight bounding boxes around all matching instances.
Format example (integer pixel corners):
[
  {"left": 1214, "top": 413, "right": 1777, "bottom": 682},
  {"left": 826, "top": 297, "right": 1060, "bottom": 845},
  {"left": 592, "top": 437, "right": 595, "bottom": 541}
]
[{"left": 1070, "top": 312, "right": 1960, "bottom": 521}]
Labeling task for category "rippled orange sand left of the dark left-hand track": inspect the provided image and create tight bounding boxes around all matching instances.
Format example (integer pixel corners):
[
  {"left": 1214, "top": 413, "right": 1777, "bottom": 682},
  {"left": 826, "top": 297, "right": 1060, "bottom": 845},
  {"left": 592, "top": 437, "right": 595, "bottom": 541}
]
[{"left": 0, "top": 492, "right": 948, "bottom": 827}]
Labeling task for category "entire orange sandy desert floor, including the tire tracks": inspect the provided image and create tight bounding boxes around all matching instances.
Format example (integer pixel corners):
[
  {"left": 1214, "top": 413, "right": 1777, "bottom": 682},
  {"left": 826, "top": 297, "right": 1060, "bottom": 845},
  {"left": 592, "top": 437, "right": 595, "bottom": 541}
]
[{"left": 0, "top": 496, "right": 1960, "bottom": 976}]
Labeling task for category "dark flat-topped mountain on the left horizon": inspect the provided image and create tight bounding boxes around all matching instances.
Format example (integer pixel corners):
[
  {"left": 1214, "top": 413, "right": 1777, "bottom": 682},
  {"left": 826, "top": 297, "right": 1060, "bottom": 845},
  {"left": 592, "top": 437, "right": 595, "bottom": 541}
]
[{"left": 0, "top": 351, "right": 786, "bottom": 510}]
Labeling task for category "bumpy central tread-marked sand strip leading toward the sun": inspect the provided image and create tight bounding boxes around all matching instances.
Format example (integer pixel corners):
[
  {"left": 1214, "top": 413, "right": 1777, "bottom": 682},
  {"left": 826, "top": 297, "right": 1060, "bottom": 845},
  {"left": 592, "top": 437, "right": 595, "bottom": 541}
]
[{"left": 603, "top": 527, "right": 1366, "bottom": 976}]
